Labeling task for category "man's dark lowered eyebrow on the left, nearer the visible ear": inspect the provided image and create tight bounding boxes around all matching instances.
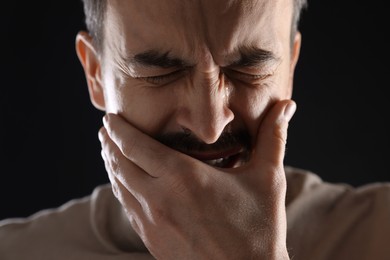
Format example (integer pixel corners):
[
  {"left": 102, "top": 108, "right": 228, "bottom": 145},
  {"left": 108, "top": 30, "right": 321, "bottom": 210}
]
[{"left": 129, "top": 50, "right": 189, "bottom": 69}]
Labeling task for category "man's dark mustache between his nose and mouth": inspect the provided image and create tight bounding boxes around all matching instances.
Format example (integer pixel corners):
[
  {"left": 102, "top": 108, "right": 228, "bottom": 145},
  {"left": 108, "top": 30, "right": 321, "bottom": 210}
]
[{"left": 155, "top": 130, "right": 251, "bottom": 154}]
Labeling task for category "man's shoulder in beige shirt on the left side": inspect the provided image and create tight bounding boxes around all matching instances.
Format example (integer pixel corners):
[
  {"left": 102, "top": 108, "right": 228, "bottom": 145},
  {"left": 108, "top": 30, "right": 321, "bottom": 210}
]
[{"left": 0, "top": 185, "right": 114, "bottom": 259}]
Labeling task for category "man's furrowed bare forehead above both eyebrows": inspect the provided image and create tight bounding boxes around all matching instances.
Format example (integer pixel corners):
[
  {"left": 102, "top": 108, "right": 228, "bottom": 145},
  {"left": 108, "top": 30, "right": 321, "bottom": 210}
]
[{"left": 105, "top": 0, "right": 292, "bottom": 62}]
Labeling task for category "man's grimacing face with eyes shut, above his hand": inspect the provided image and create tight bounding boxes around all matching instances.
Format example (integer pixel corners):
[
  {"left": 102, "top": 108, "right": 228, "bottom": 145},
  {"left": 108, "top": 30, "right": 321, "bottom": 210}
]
[{"left": 83, "top": 0, "right": 300, "bottom": 167}]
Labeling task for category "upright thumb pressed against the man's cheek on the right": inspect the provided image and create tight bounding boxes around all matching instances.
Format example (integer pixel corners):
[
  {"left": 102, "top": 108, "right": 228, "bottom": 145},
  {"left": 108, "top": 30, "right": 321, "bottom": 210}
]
[{"left": 253, "top": 100, "right": 296, "bottom": 168}]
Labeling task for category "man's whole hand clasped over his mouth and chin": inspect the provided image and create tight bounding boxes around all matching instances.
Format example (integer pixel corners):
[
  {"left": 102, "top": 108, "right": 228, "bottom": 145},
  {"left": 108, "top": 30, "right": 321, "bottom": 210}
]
[{"left": 99, "top": 100, "right": 295, "bottom": 259}]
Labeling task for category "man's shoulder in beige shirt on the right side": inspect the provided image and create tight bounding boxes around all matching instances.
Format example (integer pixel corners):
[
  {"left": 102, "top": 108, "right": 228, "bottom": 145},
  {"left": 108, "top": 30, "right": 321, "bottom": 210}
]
[{"left": 286, "top": 167, "right": 390, "bottom": 259}]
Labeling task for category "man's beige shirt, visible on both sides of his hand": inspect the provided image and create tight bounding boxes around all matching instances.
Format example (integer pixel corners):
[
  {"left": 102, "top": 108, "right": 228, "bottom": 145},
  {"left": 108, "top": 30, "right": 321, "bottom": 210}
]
[{"left": 0, "top": 167, "right": 390, "bottom": 260}]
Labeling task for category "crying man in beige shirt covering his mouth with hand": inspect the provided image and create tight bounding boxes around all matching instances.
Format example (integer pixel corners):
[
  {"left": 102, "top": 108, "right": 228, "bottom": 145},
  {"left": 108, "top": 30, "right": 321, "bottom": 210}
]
[{"left": 0, "top": 0, "right": 390, "bottom": 259}]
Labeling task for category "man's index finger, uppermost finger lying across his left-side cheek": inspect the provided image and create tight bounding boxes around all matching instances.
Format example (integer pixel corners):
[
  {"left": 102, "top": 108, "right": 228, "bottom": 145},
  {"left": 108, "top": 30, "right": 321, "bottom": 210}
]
[{"left": 103, "top": 114, "right": 191, "bottom": 177}]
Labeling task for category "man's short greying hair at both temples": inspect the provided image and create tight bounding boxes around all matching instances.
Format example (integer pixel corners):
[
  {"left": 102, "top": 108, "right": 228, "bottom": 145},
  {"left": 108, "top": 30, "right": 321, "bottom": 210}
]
[{"left": 82, "top": 0, "right": 307, "bottom": 50}]
